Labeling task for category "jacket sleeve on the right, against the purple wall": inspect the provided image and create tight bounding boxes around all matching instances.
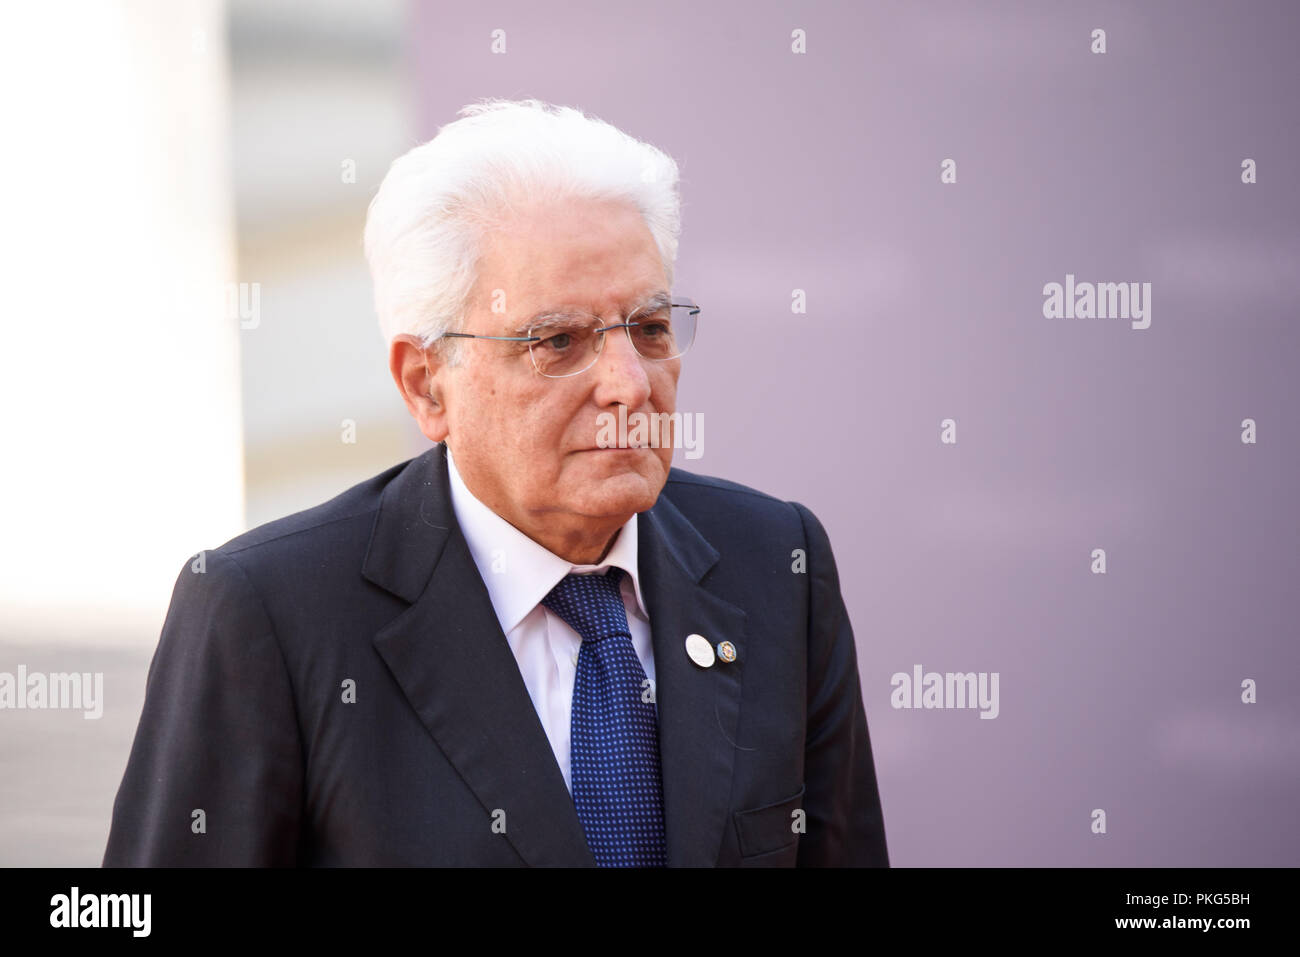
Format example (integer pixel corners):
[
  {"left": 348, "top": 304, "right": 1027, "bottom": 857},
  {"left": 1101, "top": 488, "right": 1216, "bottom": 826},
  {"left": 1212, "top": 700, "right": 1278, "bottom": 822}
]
[{"left": 792, "top": 502, "right": 889, "bottom": 867}]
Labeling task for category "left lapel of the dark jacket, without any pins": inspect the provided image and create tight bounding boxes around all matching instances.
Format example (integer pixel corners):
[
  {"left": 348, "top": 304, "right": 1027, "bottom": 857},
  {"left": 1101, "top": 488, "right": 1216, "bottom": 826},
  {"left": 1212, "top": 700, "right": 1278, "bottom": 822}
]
[{"left": 363, "top": 445, "right": 594, "bottom": 866}]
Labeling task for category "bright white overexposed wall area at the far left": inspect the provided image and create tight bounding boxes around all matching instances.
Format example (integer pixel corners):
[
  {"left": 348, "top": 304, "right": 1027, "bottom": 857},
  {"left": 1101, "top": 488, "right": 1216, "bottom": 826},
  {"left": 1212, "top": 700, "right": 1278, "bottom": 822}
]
[{"left": 0, "top": 0, "right": 244, "bottom": 648}]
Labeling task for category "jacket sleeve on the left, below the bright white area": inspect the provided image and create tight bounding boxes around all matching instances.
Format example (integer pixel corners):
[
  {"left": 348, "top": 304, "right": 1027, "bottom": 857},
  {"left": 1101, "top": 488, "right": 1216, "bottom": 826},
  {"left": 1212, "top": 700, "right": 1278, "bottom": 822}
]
[{"left": 104, "top": 551, "right": 303, "bottom": 867}]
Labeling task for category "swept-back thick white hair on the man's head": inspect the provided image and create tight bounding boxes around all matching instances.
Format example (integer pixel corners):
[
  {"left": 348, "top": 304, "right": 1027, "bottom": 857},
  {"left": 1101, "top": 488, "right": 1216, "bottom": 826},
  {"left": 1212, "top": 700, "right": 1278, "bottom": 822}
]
[{"left": 364, "top": 99, "right": 681, "bottom": 363}]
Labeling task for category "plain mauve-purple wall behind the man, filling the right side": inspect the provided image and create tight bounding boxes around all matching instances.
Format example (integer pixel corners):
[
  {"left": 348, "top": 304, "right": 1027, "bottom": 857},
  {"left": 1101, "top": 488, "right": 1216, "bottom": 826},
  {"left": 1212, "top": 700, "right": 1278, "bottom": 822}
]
[{"left": 412, "top": 0, "right": 1300, "bottom": 866}]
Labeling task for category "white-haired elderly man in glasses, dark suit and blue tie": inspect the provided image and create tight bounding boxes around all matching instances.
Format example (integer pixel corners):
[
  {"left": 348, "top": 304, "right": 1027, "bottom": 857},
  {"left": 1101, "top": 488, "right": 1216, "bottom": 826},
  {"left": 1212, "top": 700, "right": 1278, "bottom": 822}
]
[{"left": 104, "top": 100, "right": 888, "bottom": 866}]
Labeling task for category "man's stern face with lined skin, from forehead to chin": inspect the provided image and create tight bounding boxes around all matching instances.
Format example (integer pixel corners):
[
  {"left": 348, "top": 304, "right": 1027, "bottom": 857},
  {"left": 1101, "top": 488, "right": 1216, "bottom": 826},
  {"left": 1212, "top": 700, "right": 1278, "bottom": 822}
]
[{"left": 433, "top": 200, "right": 681, "bottom": 554}]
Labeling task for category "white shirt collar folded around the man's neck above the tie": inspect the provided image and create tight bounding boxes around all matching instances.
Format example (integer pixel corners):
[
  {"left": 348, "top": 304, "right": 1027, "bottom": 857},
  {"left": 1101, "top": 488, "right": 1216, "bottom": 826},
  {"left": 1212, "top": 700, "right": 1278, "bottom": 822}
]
[{"left": 447, "top": 447, "right": 649, "bottom": 635}]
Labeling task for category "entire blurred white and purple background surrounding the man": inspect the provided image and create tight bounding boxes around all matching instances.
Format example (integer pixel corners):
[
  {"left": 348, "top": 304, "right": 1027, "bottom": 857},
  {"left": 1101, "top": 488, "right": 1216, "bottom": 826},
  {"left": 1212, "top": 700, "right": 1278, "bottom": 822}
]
[{"left": 0, "top": 0, "right": 1300, "bottom": 866}]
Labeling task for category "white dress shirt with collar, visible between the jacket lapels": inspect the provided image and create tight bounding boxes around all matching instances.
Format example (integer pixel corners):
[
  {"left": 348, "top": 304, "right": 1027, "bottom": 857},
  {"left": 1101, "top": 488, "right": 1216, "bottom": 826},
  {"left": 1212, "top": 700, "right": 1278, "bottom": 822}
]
[{"left": 447, "top": 449, "right": 655, "bottom": 791}]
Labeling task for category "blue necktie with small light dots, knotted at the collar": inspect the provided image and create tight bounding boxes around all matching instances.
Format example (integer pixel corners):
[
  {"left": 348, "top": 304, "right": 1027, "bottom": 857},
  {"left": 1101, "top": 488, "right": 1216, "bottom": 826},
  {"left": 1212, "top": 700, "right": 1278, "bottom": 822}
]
[{"left": 542, "top": 568, "right": 668, "bottom": 867}]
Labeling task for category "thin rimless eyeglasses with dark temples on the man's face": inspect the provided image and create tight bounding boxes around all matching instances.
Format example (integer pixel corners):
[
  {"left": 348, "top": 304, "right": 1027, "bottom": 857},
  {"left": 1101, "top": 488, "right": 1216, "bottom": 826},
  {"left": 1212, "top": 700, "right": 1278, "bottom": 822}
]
[{"left": 434, "top": 299, "right": 699, "bottom": 378}]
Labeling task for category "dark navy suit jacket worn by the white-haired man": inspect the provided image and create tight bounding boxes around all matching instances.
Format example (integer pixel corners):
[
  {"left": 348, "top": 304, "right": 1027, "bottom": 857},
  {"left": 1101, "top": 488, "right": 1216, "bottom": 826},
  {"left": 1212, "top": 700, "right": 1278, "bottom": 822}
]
[{"left": 104, "top": 445, "right": 888, "bottom": 866}]
